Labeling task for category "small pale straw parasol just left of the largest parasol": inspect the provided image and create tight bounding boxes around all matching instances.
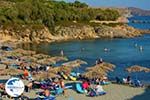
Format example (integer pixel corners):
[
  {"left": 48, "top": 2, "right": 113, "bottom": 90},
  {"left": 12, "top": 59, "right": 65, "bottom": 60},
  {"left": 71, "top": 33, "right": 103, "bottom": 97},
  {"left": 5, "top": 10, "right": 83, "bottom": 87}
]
[{"left": 62, "top": 59, "right": 87, "bottom": 68}]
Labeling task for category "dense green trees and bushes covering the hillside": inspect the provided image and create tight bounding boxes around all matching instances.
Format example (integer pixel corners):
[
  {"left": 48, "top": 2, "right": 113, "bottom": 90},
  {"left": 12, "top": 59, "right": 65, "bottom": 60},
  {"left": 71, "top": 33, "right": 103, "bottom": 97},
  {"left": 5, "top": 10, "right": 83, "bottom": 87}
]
[{"left": 0, "top": 0, "right": 120, "bottom": 31}]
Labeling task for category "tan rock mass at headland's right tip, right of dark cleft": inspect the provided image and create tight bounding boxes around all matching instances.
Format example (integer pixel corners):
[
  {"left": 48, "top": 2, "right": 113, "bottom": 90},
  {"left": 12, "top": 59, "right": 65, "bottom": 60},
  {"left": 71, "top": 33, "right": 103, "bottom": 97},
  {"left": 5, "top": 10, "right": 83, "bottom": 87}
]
[{"left": 95, "top": 25, "right": 141, "bottom": 38}]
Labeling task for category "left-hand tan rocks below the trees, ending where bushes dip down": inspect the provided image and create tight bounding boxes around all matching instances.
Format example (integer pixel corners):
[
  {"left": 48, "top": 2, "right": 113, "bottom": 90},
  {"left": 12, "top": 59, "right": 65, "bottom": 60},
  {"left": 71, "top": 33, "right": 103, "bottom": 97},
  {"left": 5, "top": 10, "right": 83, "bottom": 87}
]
[{"left": 0, "top": 27, "right": 53, "bottom": 43}]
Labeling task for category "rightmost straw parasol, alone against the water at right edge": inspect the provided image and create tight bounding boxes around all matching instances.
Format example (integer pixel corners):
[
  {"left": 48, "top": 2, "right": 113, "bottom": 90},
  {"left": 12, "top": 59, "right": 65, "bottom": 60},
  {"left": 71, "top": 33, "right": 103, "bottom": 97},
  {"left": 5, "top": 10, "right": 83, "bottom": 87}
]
[{"left": 126, "top": 65, "right": 150, "bottom": 73}]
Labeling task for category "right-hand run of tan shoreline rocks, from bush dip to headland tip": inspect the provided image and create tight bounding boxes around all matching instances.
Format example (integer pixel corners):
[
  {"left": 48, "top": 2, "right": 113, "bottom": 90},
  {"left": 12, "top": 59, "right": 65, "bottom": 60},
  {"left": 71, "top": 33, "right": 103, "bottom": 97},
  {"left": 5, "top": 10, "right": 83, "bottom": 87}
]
[{"left": 55, "top": 25, "right": 141, "bottom": 40}]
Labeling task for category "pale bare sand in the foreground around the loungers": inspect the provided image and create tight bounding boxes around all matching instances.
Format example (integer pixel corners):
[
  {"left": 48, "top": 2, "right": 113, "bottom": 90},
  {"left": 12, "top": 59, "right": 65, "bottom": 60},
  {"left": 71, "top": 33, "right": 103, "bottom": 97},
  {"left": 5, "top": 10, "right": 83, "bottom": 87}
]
[{"left": 21, "top": 84, "right": 150, "bottom": 100}]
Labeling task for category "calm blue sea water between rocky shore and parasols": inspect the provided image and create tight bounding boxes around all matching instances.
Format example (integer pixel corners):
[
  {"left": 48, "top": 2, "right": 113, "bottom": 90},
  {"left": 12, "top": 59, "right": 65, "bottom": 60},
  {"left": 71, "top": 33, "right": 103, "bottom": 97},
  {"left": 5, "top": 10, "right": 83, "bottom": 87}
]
[{"left": 21, "top": 15, "right": 150, "bottom": 83}]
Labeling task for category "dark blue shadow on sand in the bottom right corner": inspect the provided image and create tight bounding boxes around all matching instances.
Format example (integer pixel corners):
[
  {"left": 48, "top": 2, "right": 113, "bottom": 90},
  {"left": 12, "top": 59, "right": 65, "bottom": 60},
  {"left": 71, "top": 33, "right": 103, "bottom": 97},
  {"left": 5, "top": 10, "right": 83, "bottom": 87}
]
[{"left": 129, "top": 87, "right": 150, "bottom": 100}]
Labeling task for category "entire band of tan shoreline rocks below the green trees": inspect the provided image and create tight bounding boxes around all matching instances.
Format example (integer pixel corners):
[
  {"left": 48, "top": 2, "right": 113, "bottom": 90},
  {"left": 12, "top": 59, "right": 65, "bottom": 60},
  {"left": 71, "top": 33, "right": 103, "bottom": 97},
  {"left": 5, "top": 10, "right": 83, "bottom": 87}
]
[{"left": 0, "top": 25, "right": 143, "bottom": 44}]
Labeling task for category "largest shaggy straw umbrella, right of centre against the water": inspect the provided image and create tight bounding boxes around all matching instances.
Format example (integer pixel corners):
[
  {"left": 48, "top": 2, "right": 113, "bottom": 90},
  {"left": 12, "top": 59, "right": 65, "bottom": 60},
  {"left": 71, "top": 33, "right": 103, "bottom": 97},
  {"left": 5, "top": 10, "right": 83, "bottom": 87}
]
[{"left": 83, "top": 62, "right": 115, "bottom": 78}]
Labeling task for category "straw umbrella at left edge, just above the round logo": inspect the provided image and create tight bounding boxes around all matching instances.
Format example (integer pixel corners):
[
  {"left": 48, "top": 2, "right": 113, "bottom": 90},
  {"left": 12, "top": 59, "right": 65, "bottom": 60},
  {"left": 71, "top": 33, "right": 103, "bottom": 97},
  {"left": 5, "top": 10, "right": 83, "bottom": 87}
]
[{"left": 0, "top": 68, "right": 23, "bottom": 75}]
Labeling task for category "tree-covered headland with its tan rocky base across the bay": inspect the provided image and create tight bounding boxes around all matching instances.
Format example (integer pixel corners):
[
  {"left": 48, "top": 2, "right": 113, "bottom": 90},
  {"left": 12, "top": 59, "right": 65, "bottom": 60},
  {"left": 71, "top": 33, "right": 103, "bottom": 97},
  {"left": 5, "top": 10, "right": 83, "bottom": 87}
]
[{"left": 0, "top": 0, "right": 140, "bottom": 43}]
